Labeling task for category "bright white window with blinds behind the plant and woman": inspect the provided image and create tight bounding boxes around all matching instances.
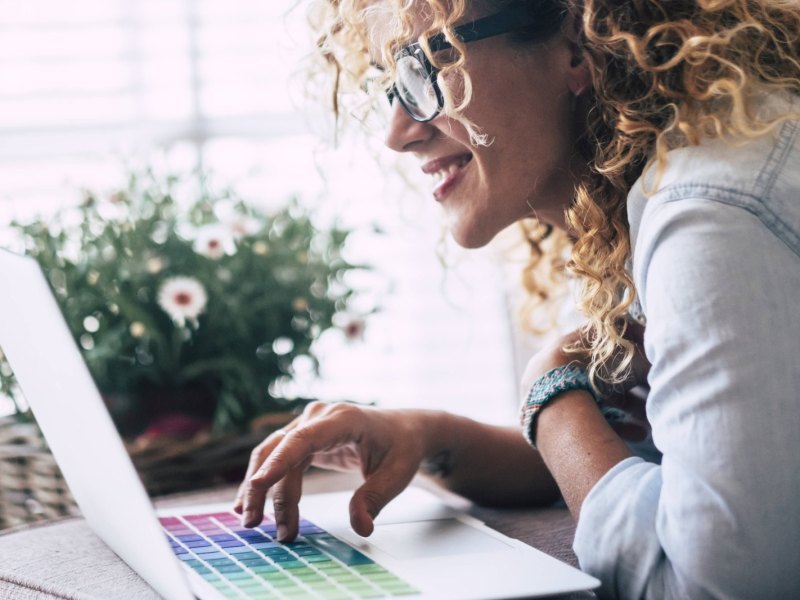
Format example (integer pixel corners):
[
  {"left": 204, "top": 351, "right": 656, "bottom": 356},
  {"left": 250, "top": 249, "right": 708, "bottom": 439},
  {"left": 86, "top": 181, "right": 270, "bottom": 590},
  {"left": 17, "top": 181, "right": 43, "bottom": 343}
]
[{"left": 0, "top": 0, "right": 516, "bottom": 422}]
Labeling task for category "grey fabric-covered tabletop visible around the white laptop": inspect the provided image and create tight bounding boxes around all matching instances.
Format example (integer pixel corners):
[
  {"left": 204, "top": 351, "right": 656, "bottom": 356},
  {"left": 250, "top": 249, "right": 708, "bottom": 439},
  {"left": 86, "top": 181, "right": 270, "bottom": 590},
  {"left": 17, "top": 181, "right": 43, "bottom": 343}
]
[{"left": 0, "top": 471, "right": 596, "bottom": 600}]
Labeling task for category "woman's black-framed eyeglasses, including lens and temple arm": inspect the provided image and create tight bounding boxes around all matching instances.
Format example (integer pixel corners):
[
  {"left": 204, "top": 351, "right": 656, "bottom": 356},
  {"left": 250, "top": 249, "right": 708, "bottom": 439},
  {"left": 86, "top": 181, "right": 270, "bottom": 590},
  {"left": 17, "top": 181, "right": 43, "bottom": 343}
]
[{"left": 386, "top": 0, "right": 564, "bottom": 123}]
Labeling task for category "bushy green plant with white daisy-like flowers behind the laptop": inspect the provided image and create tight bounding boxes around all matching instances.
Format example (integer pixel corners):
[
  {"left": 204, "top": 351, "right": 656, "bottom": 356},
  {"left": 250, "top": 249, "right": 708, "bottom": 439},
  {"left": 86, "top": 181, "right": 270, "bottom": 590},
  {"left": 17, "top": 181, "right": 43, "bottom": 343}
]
[{"left": 0, "top": 173, "right": 363, "bottom": 491}]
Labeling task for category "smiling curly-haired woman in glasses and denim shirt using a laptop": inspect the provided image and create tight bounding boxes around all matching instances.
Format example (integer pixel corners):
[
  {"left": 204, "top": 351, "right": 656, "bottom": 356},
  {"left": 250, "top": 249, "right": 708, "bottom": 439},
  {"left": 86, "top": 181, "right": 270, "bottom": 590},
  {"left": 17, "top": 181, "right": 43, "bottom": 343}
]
[{"left": 236, "top": 0, "right": 800, "bottom": 598}]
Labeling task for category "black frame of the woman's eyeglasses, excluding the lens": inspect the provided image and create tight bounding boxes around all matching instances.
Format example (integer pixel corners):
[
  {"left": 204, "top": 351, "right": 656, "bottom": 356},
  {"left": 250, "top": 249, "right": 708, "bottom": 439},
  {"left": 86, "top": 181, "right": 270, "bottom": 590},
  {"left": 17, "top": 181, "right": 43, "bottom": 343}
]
[{"left": 386, "top": 0, "right": 566, "bottom": 123}]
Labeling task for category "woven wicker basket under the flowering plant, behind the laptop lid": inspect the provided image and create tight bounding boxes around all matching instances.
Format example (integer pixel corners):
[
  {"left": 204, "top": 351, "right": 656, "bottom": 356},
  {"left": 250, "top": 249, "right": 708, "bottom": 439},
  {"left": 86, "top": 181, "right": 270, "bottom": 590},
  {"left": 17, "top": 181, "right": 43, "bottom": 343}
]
[{"left": 0, "top": 412, "right": 296, "bottom": 529}]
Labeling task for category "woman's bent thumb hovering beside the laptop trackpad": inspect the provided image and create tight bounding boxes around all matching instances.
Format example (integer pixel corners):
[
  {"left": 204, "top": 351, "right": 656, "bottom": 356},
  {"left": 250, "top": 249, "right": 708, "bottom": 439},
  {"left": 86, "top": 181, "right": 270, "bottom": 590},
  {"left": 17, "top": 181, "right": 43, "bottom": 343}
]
[{"left": 350, "top": 458, "right": 416, "bottom": 537}]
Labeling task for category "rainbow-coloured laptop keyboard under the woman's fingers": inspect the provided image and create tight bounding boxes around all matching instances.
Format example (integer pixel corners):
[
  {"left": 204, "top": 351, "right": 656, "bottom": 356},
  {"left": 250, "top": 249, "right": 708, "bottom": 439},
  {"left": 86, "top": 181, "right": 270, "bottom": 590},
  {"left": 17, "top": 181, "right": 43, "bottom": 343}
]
[{"left": 160, "top": 512, "right": 419, "bottom": 600}]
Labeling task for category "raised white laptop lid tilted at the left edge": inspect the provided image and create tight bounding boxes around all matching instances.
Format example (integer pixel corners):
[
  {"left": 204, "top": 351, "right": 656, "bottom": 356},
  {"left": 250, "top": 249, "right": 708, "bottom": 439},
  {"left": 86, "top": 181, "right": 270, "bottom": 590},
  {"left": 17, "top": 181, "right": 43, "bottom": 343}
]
[{"left": 0, "top": 250, "right": 194, "bottom": 600}]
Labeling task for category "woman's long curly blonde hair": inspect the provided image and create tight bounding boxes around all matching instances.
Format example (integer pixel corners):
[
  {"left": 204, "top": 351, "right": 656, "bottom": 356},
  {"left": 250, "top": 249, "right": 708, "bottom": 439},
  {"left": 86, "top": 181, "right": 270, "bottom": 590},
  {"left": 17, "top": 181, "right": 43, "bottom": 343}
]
[{"left": 314, "top": 0, "right": 800, "bottom": 383}]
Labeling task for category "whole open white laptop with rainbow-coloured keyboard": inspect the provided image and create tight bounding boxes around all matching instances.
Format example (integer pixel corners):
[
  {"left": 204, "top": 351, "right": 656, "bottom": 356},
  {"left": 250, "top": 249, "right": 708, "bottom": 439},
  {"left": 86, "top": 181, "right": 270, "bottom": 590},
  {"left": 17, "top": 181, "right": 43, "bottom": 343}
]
[{"left": 0, "top": 250, "right": 599, "bottom": 600}]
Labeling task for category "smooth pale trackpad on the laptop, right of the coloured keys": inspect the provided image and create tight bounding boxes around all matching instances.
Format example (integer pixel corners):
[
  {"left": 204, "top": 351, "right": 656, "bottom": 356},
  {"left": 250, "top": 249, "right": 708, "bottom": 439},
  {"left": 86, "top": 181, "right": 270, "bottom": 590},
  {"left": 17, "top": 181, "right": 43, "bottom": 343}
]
[{"left": 367, "top": 519, "right": 512, "bottom": 559}]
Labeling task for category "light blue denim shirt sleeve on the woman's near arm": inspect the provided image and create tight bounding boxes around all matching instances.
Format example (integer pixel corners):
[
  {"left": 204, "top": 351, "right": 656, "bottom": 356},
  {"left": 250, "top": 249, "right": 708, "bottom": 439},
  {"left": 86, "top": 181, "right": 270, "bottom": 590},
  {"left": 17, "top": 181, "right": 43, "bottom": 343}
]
[{"left": 574, "top": 198, "right": 800, "bottom": 599}]
